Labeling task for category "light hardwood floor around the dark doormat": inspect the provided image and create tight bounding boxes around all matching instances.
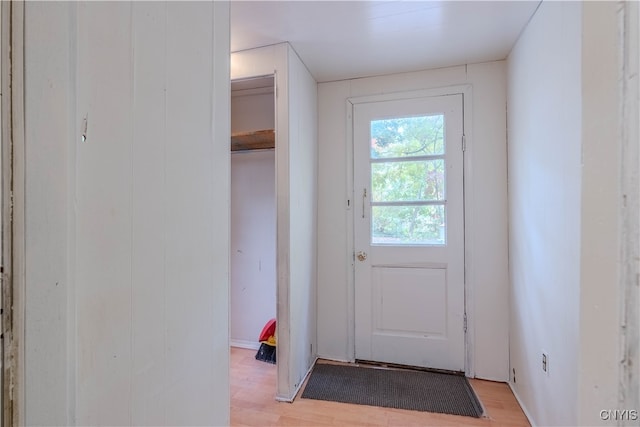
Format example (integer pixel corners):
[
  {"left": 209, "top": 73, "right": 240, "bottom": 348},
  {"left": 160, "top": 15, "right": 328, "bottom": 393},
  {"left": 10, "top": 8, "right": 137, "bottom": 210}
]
[{"left": 231, "top": 347, "right": 529, "bottom": 427}]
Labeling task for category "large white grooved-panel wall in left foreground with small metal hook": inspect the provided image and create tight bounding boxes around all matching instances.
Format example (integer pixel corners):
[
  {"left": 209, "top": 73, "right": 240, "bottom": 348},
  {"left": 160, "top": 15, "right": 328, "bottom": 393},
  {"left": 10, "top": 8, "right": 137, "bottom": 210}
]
[{"left": 25, "top": 2, "right": 230, "bottom": 425}]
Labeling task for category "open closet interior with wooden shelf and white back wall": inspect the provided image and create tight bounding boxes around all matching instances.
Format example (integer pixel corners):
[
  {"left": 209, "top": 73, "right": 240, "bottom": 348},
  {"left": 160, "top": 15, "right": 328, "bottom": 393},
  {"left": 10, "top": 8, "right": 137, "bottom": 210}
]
[{"left": 230, "top": 75, "right": 277, "bottom": 397}]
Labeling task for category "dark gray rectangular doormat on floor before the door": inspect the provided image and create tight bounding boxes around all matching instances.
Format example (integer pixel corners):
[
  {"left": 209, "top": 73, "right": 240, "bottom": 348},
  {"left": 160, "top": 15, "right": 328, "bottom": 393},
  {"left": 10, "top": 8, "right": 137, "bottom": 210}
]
[{"left": 302, "top": 363, "right": 482, "bottom": 418}]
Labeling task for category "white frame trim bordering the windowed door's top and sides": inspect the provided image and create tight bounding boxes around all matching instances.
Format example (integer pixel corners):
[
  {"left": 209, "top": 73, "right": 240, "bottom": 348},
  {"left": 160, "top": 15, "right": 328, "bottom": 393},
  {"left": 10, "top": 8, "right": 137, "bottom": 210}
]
[{"left": 345, "top": 84, "right": 475, "bottom": 377}]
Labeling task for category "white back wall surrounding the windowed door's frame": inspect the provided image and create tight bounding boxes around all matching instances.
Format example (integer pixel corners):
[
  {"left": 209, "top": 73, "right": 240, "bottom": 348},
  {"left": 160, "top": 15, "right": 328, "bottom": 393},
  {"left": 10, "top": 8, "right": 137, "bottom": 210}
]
[{"left": 318, "top": 62, "right": 509, "bottom": 381}]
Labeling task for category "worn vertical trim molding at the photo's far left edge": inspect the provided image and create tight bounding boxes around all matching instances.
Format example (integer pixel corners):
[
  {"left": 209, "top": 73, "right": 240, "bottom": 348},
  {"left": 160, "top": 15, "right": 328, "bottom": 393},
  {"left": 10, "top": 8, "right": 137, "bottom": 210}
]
[{"left": 0, "top": 2, "right": 26, "bottom": 425}]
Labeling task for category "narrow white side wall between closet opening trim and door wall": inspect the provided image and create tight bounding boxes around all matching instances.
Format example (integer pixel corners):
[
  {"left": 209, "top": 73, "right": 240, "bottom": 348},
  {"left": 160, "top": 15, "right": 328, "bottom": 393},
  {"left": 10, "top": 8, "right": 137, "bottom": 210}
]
[{"left": 284, "top": 46, "right": 318, "bottom": 397}]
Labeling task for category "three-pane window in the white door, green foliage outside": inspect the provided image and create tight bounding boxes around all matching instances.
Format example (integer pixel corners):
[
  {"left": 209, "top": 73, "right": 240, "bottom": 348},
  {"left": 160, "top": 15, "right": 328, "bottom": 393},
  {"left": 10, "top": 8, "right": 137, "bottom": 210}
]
[{"left": 370, "top": 114, "right": 447, "bottom": 246}]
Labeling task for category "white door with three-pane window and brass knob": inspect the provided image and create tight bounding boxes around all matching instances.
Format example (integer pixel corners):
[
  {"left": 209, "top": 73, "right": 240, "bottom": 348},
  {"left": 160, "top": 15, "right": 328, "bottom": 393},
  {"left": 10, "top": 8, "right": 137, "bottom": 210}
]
[{"left": 353, "top": 95, "right": 465, "bottom": 371}]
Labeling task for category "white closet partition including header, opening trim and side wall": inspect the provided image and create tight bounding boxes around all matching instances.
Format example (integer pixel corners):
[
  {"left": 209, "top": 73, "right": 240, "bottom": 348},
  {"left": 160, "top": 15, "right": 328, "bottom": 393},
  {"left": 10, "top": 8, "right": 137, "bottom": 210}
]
[{"left": 231, "top": 43, "right": 317, "bottom": 400}]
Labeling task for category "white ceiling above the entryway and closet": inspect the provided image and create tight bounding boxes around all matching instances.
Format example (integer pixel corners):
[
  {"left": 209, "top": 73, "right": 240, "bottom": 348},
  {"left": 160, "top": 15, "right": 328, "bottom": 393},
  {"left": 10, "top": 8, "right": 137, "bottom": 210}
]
[{"left": 231, "top": 0, "right": 539, "bottom": 82}]
